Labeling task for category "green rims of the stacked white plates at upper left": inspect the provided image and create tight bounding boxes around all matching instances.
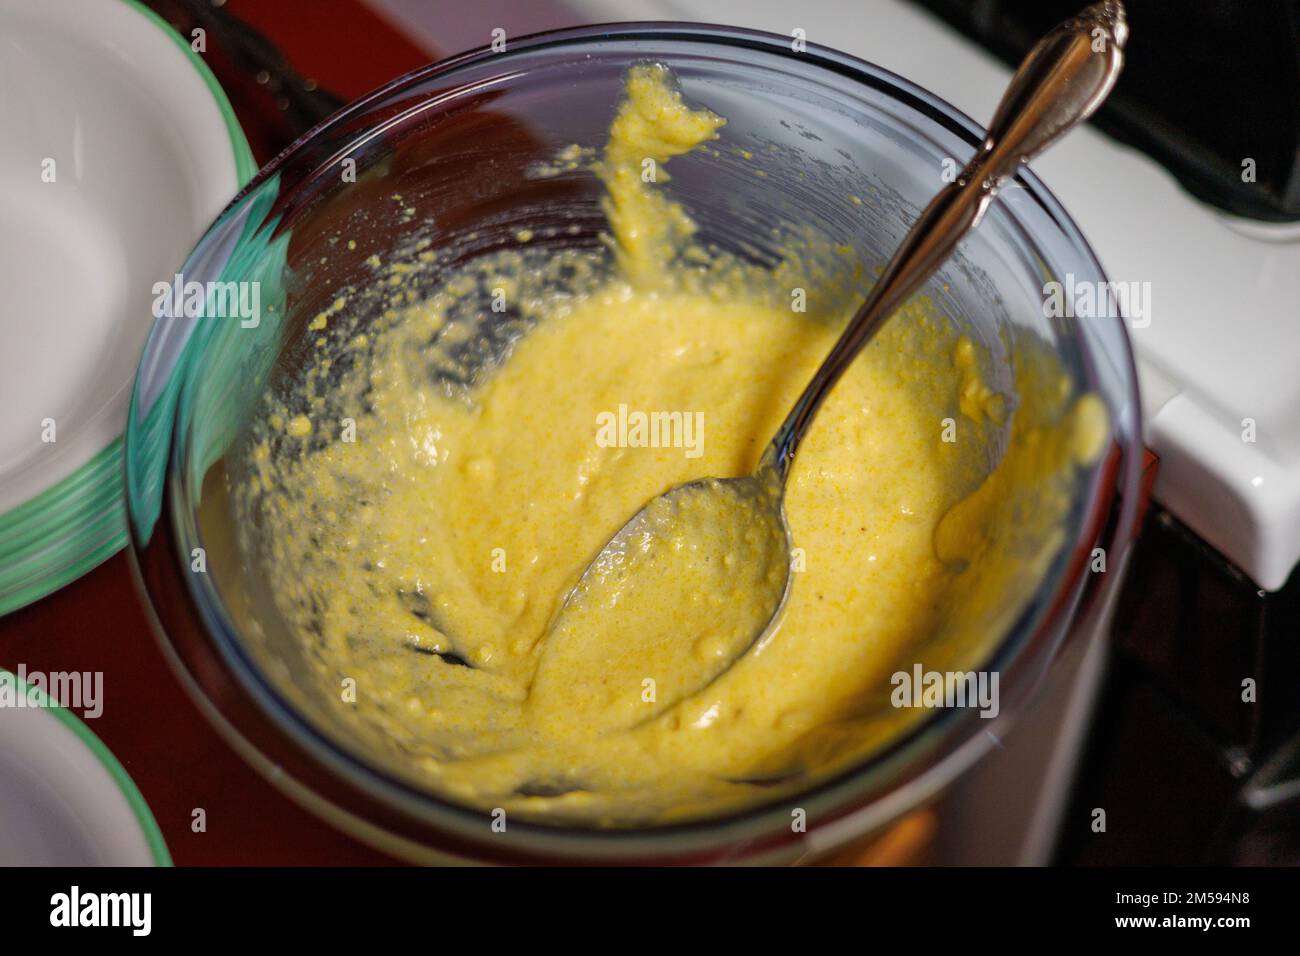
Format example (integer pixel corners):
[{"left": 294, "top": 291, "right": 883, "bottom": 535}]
[{"left": 0, "top": 0, "right": 257, "bottom": 615}]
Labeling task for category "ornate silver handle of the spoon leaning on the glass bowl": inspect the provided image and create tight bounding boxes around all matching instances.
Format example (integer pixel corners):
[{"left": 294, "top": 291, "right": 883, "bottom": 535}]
[{"left": 761, "top": 0, "right": 1128, "bottom": 483}]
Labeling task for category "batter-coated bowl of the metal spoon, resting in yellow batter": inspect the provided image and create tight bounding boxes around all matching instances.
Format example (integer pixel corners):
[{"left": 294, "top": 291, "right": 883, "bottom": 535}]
[{"left": 529, "top": 468, "right": 790, "bottom": 732}]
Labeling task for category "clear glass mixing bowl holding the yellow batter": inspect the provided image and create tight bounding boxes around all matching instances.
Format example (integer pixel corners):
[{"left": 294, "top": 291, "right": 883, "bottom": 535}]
[{"left": 126, "top": 23, "right": 1140, "bottom": 864}]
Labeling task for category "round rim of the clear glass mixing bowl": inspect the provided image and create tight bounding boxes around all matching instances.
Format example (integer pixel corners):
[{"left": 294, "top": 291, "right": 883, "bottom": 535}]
[{"left": 127, "top": 21, "right": 1141, "bottom": 861}]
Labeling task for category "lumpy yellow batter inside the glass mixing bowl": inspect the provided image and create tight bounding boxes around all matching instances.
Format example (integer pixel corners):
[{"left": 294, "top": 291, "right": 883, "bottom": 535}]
[{"left": 235, "top": 66, "right": 1108, "bottom": 825}]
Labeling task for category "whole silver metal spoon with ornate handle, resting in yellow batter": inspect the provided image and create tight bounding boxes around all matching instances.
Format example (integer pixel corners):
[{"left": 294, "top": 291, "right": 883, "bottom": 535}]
[{"left": 530, "top": 0, "right": 1128, "bottom": 731}]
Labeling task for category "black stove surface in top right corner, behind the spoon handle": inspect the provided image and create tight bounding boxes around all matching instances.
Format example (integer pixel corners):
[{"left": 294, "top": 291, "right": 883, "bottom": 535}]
[{"left": 913, "top": 0, "right": 1300, "bottom": 222}]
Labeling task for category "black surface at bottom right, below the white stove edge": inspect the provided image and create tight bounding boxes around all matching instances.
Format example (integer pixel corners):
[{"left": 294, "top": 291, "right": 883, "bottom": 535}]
[{"left": 1058, "top": 509, "right": 1300, "bottom": 865}]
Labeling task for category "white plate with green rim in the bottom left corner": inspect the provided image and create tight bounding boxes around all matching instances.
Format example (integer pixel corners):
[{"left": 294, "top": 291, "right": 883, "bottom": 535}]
[{"left": 0, "top": 674, "right": 172, "bottom": 866}]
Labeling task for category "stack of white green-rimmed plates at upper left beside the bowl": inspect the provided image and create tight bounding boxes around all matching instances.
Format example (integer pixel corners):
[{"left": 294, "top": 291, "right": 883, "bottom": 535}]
[{"left": 0, "top": 0, "right": 254, "bottom": 613}]
